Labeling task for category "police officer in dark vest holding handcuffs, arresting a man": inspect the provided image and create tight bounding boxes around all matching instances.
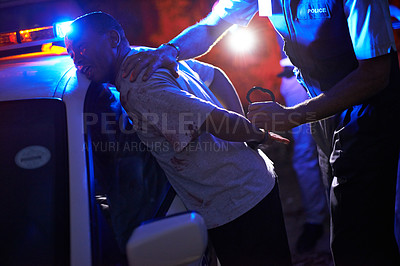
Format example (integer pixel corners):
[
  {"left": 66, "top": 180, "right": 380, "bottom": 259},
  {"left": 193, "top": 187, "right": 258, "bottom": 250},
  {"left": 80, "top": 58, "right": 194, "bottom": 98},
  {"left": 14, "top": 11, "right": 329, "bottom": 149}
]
[{"left": 125, "top": 0, "right": 400, "bottom": 265}]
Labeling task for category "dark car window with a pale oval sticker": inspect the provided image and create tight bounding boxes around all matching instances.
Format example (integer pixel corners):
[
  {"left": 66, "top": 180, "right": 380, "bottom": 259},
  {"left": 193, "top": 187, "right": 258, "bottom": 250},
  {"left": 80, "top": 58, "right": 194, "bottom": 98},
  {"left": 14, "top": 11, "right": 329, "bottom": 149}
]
[{"left": 0, "top": 99, "right": 70, "bottom": 265}]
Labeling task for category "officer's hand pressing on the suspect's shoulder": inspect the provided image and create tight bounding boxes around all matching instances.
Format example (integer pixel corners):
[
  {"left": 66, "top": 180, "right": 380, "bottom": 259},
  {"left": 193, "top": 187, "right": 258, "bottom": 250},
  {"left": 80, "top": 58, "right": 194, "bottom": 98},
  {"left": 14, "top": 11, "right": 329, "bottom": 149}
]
[{"left": 122, "top": 45, "right": 178, "bottom": 82}]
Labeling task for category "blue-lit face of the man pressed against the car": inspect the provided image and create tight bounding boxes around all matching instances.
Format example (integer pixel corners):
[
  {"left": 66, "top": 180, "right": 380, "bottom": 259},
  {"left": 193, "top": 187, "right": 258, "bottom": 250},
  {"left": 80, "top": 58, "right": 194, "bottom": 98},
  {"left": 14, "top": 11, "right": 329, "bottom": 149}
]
[{"left": 65, "top": 27, "right": 114, "bottom": 83}]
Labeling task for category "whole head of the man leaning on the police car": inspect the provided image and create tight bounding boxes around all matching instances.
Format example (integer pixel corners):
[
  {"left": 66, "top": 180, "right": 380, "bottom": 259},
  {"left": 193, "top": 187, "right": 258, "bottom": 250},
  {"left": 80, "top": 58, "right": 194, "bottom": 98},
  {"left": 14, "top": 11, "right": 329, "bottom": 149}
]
[{"left": 65, "top": 12, "right": 130, "bottom": 83}]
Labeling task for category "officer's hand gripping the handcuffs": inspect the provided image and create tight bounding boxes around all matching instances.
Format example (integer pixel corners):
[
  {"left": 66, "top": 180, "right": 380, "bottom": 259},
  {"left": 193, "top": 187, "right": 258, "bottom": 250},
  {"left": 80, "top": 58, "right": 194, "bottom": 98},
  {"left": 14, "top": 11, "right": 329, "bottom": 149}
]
[{"left": 247, "top": 102, "right": 299, "bottom": 132}]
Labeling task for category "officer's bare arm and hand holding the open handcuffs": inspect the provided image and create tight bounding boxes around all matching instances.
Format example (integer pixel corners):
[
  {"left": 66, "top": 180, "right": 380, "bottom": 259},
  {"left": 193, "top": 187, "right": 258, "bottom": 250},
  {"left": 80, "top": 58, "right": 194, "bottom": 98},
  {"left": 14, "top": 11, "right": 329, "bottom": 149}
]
[{"left": 247, "top": 54, "right": 391, "bottom": 131}]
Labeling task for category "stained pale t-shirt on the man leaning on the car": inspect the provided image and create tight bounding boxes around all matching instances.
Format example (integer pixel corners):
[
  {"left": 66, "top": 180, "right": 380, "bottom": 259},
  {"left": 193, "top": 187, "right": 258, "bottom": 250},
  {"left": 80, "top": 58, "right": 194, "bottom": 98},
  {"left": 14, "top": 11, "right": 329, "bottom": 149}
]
[{"left": 116, "top": 50, "right": 275, "bottom": 228}]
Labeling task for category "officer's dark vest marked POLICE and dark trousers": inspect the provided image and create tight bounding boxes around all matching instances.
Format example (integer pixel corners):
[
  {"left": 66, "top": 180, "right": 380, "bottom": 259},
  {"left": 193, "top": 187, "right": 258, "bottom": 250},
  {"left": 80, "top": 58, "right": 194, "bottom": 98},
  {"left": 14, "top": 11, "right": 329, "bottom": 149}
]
[{"left": 220, "top": 0, "right": 400, "bottom": 265}]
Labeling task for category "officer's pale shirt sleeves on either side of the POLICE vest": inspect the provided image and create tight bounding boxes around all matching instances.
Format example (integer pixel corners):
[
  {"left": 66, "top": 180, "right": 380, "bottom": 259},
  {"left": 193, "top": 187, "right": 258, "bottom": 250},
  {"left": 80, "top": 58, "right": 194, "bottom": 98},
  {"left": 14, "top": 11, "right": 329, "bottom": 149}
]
[{"left": 213, "top": 0, "right": 396, "bottom": 59}]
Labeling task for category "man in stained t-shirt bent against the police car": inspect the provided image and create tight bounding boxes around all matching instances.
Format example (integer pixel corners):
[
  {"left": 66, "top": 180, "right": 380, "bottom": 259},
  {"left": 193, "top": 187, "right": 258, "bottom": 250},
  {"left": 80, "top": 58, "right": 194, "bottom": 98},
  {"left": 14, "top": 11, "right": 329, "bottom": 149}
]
[{"left": 65, "top": 12, "right": 291, "bottom": 265}]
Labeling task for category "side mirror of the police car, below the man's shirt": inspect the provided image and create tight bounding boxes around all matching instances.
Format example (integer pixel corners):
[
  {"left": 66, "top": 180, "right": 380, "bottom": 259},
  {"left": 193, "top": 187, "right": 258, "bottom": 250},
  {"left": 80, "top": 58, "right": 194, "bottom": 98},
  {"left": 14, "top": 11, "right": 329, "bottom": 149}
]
[{"left": 126, "top": 212, "right": 208, "bottom": 266}]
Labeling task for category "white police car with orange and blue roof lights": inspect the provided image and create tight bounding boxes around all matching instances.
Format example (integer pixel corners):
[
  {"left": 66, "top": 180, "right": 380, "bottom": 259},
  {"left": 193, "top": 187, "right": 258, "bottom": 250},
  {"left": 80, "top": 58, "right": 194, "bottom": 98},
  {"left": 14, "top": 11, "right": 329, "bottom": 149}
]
[{"left": 0, "top": 19, "right": 211, "bottom": 265}]
